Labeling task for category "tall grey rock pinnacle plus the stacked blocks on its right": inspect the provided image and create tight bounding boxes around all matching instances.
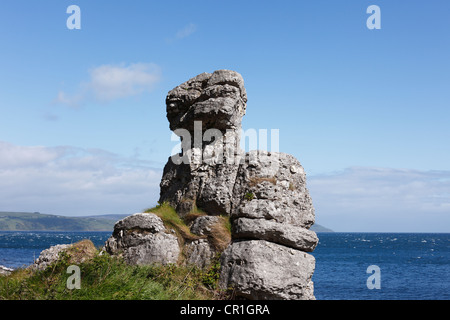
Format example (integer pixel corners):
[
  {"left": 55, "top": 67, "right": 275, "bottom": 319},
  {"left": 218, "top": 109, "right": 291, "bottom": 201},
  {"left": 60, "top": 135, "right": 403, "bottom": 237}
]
[{"left": 160, "top": 70, "right": 318, "bottom": 299}]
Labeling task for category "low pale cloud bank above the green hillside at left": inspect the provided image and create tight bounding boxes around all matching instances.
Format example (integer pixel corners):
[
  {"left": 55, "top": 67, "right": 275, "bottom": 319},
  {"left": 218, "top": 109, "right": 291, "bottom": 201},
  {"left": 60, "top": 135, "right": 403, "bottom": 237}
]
[{"left": 0, "top": 141, "right": 162, "bottom": 215}]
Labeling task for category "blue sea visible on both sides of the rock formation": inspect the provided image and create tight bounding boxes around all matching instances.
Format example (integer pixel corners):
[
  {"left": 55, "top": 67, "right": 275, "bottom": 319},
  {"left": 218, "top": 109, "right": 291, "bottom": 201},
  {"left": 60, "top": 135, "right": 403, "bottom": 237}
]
[{"left": 0, "top": 231, "right": 450, "bottom": 300}]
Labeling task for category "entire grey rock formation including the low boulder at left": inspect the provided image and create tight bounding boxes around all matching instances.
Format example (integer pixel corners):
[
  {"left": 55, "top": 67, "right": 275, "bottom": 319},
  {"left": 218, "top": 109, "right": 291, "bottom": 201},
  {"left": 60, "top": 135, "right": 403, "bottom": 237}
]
[{"left": 105, "top": 70, "right": 318, "bottom": 299}]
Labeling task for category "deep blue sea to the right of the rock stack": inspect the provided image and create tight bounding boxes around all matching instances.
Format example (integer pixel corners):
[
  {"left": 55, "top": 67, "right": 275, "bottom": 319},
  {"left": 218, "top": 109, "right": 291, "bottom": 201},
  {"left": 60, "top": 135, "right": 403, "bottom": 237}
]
[{"left": 312, "top": 233, "right": 450, "bottom": 300}]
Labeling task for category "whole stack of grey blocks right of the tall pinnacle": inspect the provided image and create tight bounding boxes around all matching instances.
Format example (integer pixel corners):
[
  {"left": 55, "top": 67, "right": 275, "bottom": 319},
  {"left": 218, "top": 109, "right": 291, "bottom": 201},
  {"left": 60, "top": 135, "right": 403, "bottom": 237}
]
[{"left": 217, "top": 151, "right": 318, "bottom": 300}]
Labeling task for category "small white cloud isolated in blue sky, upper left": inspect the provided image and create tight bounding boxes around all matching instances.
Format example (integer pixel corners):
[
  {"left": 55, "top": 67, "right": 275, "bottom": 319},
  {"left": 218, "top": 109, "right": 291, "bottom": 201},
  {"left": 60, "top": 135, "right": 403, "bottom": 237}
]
[{"left": 55, "top": 63, "right": 161, "bottom": 107}]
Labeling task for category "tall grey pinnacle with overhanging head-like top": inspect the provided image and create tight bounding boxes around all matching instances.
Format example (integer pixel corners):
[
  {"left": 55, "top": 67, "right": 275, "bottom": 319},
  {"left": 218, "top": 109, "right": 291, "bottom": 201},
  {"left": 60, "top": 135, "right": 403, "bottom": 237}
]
[{"left": 159, "top": 70, "right": 247, "bottom": 215}]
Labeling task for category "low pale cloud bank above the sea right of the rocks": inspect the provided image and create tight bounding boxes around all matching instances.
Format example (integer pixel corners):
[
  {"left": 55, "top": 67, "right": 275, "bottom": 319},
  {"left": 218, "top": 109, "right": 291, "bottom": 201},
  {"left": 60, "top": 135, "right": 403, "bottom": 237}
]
[{"left": 308, "top": 167, "right": 450, "bottom": 232}]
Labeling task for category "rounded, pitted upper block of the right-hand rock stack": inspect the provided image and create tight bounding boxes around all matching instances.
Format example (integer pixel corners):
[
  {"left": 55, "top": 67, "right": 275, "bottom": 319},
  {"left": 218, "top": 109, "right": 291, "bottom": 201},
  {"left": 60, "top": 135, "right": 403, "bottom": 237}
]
[{"left": 232, "top": 151, "right": 314, "bottom": 228}]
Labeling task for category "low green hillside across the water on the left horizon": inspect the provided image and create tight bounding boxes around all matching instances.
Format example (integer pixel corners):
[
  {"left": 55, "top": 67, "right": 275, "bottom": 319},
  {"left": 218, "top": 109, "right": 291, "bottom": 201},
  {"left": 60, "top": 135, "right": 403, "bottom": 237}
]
[{"left": 0, "top": 211, "right": 119, "bottom": 231}]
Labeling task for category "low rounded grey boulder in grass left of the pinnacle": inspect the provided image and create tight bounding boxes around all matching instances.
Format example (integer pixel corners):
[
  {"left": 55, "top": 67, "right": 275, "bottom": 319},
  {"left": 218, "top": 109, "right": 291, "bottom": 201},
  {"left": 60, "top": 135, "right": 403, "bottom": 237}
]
[{"left": 104, "top": 213, "right": 180, "bottom": 265}]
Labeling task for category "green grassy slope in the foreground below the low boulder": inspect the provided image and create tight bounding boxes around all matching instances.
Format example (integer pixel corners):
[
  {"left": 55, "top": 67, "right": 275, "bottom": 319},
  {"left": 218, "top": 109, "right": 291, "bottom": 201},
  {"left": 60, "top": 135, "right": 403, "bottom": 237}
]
[{"left": 0, "top": 240, "right": 225, "bottom": 300}]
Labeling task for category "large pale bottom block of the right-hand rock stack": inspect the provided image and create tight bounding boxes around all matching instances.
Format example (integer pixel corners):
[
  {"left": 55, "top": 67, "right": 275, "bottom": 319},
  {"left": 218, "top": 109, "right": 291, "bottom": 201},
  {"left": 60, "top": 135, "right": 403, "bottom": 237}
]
[{"left": 220, "top": 240, "right": 315, "bottom": 300}]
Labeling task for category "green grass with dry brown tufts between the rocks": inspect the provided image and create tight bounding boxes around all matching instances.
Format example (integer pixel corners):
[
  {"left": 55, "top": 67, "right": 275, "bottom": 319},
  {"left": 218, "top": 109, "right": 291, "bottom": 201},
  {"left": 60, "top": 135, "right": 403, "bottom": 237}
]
[{"left": 0, "top": 203, "right": 231, "bottom": 300}]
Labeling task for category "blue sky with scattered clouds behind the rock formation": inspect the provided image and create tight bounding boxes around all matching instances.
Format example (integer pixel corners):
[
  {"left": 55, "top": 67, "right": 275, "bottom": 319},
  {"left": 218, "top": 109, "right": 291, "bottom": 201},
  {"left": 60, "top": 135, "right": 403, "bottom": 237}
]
[{"left": 0, "top": 0, "right": 450, "bottom": 232}]
